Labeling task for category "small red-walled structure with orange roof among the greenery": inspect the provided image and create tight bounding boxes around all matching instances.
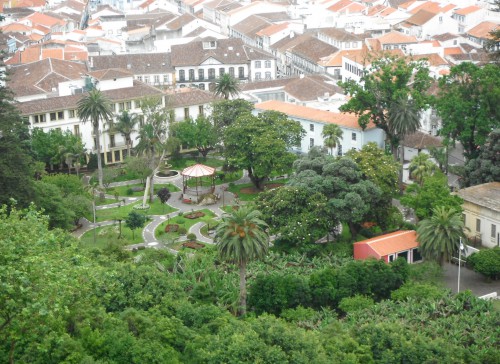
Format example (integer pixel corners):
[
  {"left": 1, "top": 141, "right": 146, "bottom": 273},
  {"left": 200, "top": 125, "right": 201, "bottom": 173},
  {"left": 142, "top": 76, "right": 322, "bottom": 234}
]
[{"left": 354, "top": 230, "right": 422, "bottom": 263}]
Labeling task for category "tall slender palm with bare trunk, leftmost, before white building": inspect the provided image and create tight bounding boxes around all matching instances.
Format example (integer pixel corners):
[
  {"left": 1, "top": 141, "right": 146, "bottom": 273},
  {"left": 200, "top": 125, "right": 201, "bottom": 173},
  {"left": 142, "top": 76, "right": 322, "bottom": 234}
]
[{"left": 78, "top": 89, "right": 113, "bottom": 188}]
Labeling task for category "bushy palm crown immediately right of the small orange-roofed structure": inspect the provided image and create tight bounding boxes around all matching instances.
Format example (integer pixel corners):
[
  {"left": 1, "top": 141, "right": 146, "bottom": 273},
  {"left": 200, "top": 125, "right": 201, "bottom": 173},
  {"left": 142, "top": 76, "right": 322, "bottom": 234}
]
[{"left": 417, "top": 206, "right": 466, "bottom": 265}]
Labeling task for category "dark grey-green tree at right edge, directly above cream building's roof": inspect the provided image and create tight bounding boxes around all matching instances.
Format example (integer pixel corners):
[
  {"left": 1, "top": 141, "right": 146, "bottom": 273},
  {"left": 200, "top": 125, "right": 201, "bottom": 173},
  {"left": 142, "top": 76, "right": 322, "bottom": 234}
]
[{"left": 461, "top": 129, "right": 500, "bottom": 187}]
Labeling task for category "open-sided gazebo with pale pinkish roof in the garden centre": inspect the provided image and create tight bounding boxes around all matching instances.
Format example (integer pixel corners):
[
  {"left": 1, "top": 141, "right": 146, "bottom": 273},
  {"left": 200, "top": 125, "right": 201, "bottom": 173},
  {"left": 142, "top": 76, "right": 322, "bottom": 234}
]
[{"left": 181, "top": 164, "right": 215, "bottom": 203}]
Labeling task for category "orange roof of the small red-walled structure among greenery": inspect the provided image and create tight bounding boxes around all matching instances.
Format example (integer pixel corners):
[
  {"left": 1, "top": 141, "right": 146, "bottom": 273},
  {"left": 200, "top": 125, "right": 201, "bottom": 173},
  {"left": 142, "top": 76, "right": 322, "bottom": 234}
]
[{"left": 354, "top": 230, "right": 419, "bottom": 258}]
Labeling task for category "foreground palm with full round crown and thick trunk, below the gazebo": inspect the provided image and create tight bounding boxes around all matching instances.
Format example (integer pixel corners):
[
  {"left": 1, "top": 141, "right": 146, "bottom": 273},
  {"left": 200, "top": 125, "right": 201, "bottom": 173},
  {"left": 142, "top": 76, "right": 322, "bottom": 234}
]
[{"left": 215, "top": 206, "right": 269, "bottom": 315}]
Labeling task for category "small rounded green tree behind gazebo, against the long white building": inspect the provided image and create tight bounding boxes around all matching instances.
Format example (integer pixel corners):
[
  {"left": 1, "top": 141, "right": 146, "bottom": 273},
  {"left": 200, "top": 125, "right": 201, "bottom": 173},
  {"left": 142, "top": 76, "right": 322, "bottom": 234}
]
[{"left": 172, "top": 115, "right": 219, "bottom": 158}]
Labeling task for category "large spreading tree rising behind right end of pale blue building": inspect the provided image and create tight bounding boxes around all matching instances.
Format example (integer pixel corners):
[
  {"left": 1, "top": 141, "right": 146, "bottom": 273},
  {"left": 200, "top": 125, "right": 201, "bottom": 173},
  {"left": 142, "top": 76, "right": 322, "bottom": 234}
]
[{"left": 340, "top": 55, "right": 432, "bottom": 159}]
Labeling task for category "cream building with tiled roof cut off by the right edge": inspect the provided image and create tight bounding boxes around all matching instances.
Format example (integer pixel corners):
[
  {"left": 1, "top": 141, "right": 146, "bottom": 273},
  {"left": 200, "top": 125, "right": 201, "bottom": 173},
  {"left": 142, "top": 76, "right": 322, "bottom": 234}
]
[{"left": 457, "top": 182, "right": 500, "bottom": 248}]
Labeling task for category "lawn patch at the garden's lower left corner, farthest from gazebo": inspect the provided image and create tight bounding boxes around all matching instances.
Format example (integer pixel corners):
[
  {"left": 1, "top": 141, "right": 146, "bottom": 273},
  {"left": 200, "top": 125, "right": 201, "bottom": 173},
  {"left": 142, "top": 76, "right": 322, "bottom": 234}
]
[{"left": 80, "top": 222, "right": 143, "bottom": 249}]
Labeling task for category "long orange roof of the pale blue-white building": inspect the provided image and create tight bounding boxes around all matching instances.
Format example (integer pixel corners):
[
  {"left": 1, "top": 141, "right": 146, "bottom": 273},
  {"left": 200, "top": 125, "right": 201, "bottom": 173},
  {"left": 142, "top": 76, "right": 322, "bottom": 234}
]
[{"left": 255, "top": 100, "right": 375, "bottom": 130}]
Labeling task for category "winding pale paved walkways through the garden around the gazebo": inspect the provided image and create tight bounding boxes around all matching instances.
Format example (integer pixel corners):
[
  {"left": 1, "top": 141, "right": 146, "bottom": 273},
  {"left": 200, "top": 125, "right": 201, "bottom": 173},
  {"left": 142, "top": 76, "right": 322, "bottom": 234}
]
[{"left": 73, "top": 167, "right": 250, "bottom": 254}]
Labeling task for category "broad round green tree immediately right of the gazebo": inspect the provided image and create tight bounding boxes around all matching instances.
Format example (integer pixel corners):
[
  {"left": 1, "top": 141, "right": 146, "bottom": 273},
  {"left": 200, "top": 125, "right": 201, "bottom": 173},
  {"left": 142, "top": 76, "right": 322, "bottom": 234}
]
[{"left": 224, "top": 111, "right": 305, "bottom": 190}]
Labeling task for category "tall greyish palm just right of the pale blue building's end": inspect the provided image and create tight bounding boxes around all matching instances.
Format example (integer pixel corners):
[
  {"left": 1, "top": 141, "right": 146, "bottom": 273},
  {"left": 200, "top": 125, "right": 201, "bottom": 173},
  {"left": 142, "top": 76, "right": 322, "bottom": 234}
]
[{"left": 388, "top": 96, "right": 420, "bottom": 192}]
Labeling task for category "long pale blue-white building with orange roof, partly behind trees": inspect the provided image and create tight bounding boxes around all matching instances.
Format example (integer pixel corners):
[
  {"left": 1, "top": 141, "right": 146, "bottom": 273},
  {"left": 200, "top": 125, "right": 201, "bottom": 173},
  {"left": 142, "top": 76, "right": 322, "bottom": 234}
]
[{"left": 255, "top": 100, "right": 385, "bottom": 155}]
